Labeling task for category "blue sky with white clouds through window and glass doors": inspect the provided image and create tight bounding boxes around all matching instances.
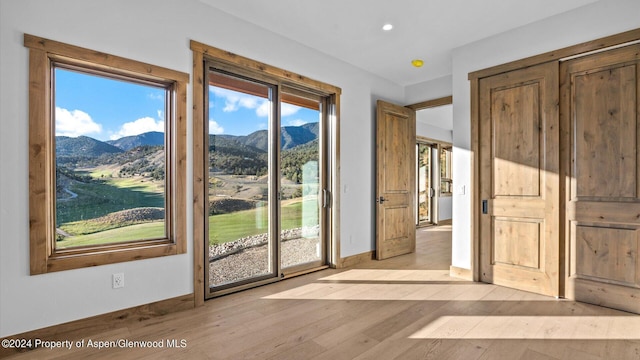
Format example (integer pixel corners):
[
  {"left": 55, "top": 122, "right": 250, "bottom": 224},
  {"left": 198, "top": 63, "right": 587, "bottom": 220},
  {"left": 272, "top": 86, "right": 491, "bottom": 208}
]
[{"left": 55, "top": 68, "right": 318, "bottom": 141}]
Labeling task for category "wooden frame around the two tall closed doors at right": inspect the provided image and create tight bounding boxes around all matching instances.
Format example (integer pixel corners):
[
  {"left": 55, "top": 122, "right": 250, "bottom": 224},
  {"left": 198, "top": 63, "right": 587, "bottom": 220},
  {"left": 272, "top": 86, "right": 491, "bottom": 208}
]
[{"left": 468, "top": 29, "right": 640, "bottom": 284}]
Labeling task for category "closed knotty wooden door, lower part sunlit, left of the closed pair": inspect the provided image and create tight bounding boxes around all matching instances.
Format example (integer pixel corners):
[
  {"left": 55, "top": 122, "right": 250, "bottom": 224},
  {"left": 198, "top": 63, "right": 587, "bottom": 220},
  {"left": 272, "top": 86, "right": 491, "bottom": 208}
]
[{"left": 479, "top": 62, "right": 560, "bottom": 296}]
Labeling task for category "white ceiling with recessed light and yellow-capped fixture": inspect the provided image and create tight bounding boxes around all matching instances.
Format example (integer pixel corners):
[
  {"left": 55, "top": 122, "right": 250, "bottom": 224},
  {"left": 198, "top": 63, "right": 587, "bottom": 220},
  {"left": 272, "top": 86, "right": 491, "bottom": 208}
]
[{"left": 200, "top": 0, "right": 597, "bottom": 86}]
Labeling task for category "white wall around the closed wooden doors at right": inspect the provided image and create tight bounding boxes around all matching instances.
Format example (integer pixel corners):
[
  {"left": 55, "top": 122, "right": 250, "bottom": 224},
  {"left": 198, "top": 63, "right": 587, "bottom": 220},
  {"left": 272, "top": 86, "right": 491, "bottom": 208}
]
[{"left": 452, "top": 0, "right": 640, "bottom": 269}]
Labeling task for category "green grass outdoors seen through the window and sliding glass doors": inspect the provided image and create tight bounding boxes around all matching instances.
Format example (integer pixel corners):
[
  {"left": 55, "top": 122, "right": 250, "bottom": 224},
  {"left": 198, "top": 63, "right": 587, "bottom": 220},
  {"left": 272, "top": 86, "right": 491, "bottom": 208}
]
[{"left": 56, "top": 170, "right": 315, "bottom": 248}]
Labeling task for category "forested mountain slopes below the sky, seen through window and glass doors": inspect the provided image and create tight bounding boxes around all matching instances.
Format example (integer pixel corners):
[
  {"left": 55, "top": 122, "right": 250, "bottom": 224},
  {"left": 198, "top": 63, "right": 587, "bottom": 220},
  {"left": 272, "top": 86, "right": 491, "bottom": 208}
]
[{"left": 56, "top": 123, "right": 319, "bottom": 181}]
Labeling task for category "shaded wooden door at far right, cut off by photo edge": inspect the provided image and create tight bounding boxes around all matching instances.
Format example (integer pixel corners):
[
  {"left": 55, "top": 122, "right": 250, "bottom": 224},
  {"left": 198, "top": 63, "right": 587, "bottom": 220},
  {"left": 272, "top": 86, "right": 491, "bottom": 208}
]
[{"left": 561, "top": 45, "right": 640, "bottom": 313}]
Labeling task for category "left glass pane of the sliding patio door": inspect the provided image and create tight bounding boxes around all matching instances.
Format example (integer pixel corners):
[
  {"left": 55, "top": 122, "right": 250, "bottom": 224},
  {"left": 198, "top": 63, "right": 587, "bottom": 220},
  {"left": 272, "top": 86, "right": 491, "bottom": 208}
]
[{"left": 208, "top": 71, "right": 275, "bottom": 288}]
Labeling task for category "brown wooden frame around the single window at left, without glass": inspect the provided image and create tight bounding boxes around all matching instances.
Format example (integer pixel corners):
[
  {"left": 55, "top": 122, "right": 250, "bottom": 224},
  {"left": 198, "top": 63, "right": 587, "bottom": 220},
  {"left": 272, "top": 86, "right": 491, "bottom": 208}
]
[{"left": 24, "top": 34, "right": 189, "bottom": 275}]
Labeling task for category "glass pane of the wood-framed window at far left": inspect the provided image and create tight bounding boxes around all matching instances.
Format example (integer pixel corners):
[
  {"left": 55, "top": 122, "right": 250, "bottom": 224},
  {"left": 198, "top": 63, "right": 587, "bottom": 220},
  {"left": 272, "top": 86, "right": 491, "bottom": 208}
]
[{"left": 53, "top": 67, "right": 167, "bottom": 249}]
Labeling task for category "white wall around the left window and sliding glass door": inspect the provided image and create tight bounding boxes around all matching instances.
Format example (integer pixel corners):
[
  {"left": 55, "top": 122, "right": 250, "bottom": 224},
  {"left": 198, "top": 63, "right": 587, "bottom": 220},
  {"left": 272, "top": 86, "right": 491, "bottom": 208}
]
[{"left": 0, "top": 0, "right": 404, "bottom": 337}]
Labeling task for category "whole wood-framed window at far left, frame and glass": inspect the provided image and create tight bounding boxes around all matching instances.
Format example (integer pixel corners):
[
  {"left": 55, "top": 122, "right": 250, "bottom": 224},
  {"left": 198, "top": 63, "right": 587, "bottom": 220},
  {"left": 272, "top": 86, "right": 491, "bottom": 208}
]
[{"left": 24, "top": 35, "right": 189, "bottom": 274}]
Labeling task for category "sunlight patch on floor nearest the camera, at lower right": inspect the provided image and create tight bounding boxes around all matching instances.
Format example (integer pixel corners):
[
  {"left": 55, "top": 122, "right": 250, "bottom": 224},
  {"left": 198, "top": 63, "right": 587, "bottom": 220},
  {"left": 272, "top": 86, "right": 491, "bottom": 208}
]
[{"left": 409, "top": 315, "right": 640, "bottom": 340}]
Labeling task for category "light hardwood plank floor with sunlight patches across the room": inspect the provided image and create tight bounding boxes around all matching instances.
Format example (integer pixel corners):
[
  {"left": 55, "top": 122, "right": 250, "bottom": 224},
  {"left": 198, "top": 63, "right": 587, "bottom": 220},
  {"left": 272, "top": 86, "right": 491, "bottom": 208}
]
[{"left": 6, "top": 226, "right": 640, "bottom": 360}]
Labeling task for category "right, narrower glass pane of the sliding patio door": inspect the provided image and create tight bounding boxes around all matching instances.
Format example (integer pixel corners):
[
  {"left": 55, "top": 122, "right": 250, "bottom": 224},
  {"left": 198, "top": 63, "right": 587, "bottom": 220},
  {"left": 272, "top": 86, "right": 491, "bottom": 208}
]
[{"left": 280, "top": 93, "right": 324, "bottom": 268}]
